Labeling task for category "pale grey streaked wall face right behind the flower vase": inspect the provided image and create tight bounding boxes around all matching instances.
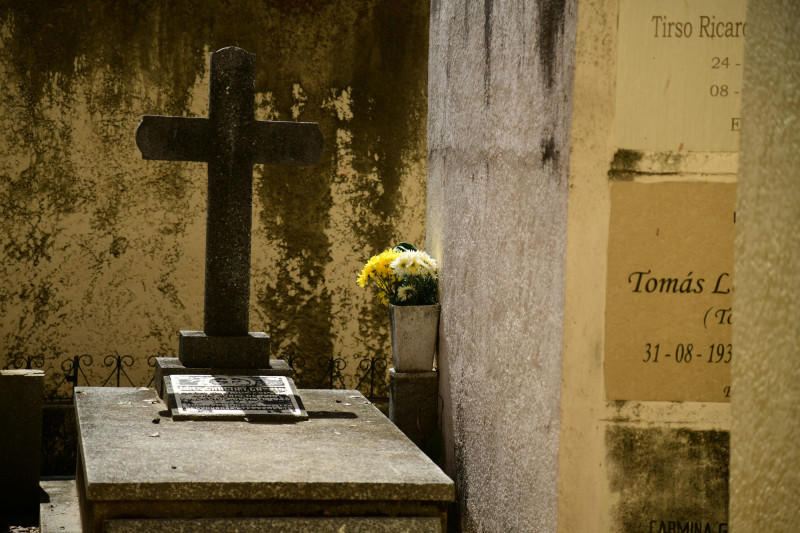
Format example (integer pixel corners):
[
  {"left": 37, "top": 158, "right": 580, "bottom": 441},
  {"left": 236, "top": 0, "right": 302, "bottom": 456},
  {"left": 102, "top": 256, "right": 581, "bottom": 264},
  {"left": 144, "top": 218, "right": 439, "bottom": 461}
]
[{"left": 427, "top": 0, "right": 575, "bottom": 532}]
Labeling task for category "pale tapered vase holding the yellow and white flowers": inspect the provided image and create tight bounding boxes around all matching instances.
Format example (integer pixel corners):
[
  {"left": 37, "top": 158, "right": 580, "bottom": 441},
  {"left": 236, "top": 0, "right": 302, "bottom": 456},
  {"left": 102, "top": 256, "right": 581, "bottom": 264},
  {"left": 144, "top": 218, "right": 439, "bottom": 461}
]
[{"left": 389, "top": 303, "right": 441, "bottom": 372}]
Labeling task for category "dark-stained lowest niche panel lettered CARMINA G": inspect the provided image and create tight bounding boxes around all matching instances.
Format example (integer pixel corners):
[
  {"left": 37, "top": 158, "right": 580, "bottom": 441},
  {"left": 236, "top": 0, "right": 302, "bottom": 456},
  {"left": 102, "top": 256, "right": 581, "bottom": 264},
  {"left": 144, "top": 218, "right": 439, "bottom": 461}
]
[{"left": 606, "top": 424, "right": 730, "bottom": 533}]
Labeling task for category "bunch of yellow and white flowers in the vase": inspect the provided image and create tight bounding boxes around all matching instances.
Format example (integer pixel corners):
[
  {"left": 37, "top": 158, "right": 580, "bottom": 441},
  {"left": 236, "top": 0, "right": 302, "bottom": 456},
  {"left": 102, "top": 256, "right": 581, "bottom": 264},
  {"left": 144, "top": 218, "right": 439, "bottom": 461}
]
[{"left": 358, "top": 242, "right": 439, "bottom": 305}]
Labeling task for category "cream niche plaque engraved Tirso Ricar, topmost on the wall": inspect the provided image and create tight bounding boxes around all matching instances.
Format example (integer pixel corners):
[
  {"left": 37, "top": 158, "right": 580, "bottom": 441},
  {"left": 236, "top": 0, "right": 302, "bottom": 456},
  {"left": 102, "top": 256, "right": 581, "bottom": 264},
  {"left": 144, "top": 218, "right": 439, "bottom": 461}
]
[{"left": 615, "top": 0, "right": 747, "bottom": 152}]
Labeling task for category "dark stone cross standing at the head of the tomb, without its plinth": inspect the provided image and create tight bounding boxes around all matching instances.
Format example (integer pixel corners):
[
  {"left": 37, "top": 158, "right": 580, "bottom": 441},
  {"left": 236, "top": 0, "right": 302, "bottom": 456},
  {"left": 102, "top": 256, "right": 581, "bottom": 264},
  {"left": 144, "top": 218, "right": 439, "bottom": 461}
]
[{"left": 136, "top": 47, "right": 323, "bottom": 367}]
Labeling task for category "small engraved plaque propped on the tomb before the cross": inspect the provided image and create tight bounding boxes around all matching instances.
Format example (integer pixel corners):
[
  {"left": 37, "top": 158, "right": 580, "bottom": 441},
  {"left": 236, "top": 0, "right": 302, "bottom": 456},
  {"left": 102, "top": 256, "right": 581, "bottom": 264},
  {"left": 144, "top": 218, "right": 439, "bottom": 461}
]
[{"left": 165, "top": 374, "right": 308, "bottom": 420}]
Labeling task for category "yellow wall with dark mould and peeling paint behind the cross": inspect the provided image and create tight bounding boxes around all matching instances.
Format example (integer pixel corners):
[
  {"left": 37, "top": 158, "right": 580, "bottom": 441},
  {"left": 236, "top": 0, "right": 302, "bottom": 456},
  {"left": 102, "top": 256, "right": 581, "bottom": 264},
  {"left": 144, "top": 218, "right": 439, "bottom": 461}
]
[{"left": 0, "top": 0, "right": 428, "bottom": 387}]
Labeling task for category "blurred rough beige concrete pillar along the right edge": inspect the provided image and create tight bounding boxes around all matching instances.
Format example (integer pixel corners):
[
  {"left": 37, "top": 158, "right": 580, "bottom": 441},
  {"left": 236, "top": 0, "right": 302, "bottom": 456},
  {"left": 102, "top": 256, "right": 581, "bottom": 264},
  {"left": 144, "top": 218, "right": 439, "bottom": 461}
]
[{"left": 731, "top": 1, "right": 800, "bottom": 533}]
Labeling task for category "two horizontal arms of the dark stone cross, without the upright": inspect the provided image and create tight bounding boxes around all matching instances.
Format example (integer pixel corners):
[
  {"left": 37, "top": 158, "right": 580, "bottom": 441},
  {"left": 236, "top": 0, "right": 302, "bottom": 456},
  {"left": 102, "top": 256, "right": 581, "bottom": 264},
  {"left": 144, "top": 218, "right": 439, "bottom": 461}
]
[{"left": 136, "top": 115, "right": 323, "bottom": 165}]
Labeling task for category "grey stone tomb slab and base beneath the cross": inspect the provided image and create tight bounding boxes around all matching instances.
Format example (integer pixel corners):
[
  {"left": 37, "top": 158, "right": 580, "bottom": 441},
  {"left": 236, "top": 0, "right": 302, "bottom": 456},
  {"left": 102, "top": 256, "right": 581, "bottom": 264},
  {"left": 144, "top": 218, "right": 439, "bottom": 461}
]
[{"left": 75, "top": 387, "right": 455, "bottom": 532}]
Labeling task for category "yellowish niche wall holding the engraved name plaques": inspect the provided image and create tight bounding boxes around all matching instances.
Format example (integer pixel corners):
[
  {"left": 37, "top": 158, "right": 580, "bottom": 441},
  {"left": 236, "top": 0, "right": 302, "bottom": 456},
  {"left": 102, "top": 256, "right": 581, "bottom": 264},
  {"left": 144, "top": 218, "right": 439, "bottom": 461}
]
[{"left": 558, "top": 0, "right": 747, "bottom": 533}]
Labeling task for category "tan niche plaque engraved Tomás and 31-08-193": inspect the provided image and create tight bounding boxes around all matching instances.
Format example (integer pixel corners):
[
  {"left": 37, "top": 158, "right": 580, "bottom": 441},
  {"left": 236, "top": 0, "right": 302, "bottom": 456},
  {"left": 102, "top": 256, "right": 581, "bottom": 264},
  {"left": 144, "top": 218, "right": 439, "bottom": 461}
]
[{"left": 605, "top": 182, "right": 736, "bottom": 402}]
